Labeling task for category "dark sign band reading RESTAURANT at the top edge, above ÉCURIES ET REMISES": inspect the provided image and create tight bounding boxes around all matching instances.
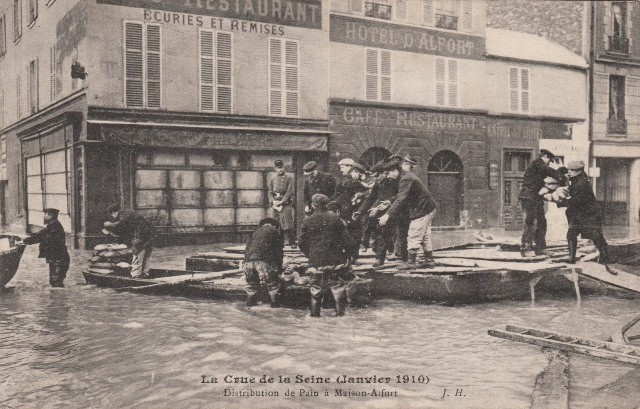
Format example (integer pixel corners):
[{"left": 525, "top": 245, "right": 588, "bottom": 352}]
[{"left": 97, "top": 0, "right": 322, "bottom": 29}]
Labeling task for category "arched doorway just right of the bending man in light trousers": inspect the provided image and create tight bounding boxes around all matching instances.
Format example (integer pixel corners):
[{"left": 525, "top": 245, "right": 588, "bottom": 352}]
[{"left": 427, "top": 151, "right": 463, "bottom": 226}]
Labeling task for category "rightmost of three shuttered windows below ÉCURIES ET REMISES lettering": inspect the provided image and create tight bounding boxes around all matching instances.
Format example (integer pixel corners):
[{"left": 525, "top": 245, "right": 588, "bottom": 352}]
[{"left": 269, "top": 38, "right": 299, "bottom": 117}]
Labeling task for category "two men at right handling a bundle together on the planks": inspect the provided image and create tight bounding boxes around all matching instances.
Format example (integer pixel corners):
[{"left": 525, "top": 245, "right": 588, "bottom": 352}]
[{"left": 519, "top": 149, "right": 611, "bottom": 271}]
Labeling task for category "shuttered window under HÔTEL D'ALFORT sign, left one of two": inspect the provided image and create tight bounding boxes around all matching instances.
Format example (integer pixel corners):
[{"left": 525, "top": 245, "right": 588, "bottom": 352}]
[{"left": 365, "top": 48, "right": 391, "bottom": 101}]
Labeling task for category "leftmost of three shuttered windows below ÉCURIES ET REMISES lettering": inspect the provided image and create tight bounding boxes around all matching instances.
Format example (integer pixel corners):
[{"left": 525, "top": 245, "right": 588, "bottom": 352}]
[{"left": 124, "top": 21, "right": 162, "bottom": 108}]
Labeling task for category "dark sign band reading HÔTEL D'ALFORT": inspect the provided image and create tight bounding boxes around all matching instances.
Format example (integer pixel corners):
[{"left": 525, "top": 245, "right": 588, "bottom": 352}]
[{"left": 330, "top": 15, "right": 485, "bottom": 60}]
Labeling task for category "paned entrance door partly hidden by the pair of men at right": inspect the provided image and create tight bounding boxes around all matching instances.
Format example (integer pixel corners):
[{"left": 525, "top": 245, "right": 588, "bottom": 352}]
[{"left": 502, "top": 151, "right": 531, "bottom": 230}]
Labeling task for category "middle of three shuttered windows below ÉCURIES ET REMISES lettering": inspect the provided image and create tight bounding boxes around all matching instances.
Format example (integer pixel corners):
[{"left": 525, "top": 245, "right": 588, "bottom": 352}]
[{"left": 200, "top": 30, "right": 232, "bottom": 113}]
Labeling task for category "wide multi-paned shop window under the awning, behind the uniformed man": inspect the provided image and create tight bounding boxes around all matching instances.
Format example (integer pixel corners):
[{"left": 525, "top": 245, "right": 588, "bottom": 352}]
[{"left": 135, "top": 151, "right": 294, "bottom": 232}]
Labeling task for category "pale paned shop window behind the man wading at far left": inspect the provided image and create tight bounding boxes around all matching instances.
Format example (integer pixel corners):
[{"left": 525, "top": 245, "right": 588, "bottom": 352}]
[{"left": 26, "top": 149, "right": 71, "bottom": 233}]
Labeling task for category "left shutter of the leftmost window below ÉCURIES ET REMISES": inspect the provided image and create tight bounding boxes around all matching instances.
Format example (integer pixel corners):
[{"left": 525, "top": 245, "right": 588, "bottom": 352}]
[{"left": 124, "top": 22, "right": 144, "bottom": 107}]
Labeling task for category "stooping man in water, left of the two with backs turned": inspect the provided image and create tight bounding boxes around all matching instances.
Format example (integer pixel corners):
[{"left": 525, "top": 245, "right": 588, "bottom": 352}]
[{"left": 243, "top": 218, "right": 284, "bottom": 307}]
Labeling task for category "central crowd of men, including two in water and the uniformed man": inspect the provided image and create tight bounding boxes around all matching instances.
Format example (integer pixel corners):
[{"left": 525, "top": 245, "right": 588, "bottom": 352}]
[{"left": 244, "top": 155, "right": 437, "bottom": 317}]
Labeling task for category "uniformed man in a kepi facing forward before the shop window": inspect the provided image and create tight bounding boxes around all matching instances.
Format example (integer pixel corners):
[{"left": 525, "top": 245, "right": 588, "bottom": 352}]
[{"left": 269, "top": 159, "right": 296, "bottom": 247}]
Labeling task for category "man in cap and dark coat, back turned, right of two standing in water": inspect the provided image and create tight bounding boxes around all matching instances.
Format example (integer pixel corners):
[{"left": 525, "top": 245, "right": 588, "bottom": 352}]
[{"left": 298, "top": 194, "right": 358, "bottom": 317}]
